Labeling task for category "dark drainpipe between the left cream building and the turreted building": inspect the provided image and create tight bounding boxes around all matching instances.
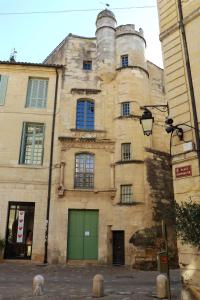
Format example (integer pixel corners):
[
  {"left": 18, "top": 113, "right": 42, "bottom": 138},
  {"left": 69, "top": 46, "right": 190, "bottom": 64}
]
[{"left": 44, "top": 68, "right": 59, "bottom": 264}]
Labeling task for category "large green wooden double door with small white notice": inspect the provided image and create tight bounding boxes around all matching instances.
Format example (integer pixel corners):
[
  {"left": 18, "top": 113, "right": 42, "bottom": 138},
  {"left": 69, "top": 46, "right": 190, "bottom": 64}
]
[{"left": 68, "top": 210, "right": 98, "bottom": 260}]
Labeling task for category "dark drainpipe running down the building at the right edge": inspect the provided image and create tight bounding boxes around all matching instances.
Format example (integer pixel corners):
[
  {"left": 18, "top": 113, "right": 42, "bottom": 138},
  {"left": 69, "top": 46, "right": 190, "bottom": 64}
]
[{"left": 178, "top": 0, "right": 200, "bottom": 173}]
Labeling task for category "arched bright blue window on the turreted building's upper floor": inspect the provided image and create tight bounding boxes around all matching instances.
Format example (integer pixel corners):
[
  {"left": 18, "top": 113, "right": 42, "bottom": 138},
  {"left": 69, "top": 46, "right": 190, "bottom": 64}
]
[{"left": 76, "top": 99, "right": 94, "bottom": 130}]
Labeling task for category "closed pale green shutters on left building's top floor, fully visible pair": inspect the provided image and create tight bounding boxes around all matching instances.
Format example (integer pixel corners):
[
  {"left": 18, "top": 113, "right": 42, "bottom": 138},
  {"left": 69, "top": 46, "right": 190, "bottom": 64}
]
[{"left": 26, "top": 78, "right": 48, "bottom": 108}]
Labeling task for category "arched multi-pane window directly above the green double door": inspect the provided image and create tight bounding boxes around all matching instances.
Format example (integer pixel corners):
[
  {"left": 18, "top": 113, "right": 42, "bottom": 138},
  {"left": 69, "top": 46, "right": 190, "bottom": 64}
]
[{"left": 74, "top": 153, "right": 94, "bottom": 189}]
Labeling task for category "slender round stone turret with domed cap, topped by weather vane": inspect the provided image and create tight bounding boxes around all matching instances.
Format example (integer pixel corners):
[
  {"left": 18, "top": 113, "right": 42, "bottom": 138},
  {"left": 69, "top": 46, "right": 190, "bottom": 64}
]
[{"left": 96, "top": 9, "right": 116, "bottom": 81}]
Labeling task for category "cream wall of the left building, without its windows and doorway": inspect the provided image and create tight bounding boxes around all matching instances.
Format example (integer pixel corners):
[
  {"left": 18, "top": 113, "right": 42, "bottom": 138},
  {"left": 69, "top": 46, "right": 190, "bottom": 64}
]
[{"left": 0, "top": 62, "right": 61, "bottom": 261}]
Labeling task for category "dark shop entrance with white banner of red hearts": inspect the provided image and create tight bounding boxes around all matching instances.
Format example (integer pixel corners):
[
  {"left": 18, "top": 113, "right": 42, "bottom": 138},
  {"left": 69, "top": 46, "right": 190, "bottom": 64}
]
[{"left": 4, "top": 202, "right": 35, "bottom": 259}]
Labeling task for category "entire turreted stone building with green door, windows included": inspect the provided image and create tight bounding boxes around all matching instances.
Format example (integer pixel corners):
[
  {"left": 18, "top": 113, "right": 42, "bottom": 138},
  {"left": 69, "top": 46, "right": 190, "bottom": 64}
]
[{"left": 44, "top": 10, "right": 173, "bottom": 264}]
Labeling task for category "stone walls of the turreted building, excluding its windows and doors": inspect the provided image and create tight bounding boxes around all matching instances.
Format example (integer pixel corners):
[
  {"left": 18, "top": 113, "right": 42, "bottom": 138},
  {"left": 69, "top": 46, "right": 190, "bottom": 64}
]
[{"left": 45, "top": 10, "right": 172, "bottom": 264}]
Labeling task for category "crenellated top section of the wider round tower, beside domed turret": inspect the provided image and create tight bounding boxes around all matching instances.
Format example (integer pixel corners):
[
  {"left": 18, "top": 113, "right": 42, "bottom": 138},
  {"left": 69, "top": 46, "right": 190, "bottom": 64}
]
[{"left": 116, "top": 24, "right": 147, "bottom": 70}]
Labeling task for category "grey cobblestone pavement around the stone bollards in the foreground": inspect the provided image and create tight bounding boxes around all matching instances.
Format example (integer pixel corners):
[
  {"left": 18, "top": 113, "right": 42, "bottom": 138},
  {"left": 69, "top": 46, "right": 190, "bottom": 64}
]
[{"left": 0, "top": 262, "right": 180, "bottom": 300}]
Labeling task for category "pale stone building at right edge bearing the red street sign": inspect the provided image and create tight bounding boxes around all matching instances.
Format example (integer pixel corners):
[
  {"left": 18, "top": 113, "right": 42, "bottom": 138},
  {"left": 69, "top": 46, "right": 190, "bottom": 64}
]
[{"left": 157, "top": 0, "right": 200, "bottom": 299}]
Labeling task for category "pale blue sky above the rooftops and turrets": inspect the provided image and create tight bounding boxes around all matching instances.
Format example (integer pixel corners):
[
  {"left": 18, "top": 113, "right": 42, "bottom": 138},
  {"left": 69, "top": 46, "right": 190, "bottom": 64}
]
[{"left": 0, "top": 0, "right": 163, "bottom": 67}]
